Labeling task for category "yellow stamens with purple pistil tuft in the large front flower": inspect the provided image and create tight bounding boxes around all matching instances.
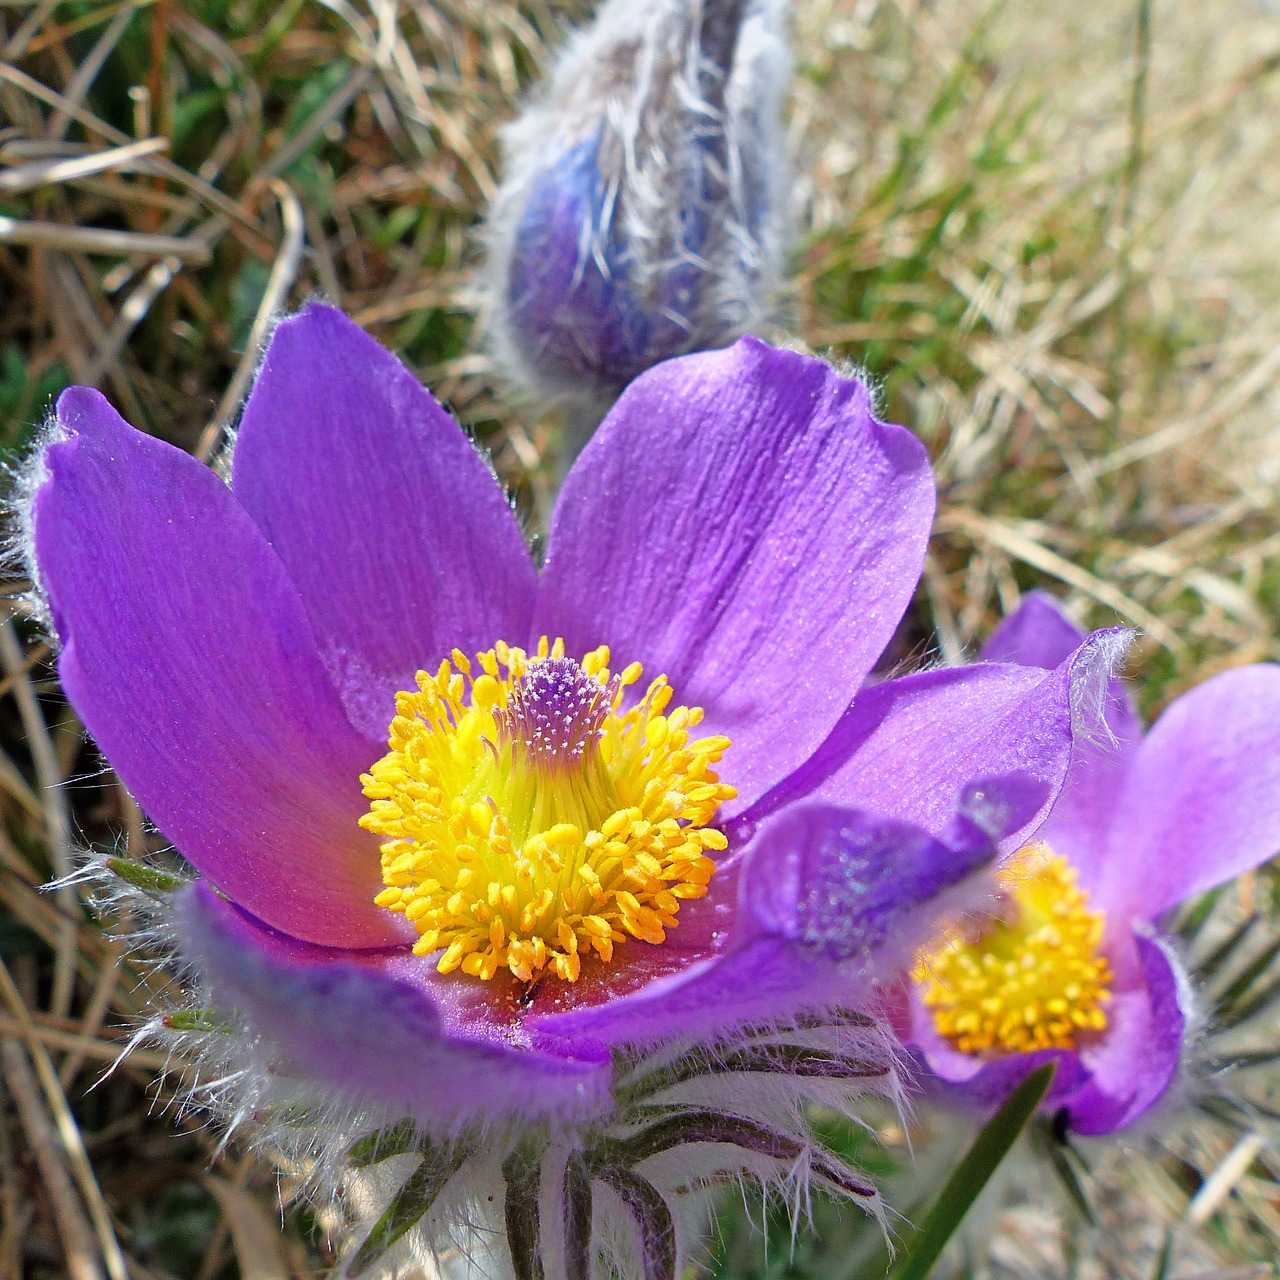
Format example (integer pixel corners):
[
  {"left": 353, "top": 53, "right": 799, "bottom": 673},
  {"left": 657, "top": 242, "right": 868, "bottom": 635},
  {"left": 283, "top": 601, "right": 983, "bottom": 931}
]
[{"left": 360, "top": 636, "right": 737, "bottom": 982}]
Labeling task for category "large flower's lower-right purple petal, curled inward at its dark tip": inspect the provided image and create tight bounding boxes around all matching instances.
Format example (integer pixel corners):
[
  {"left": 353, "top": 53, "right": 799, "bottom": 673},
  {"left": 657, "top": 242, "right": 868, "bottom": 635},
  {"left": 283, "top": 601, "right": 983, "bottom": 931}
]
[{"left": 536, "top": 780, "right": 1041, "bottom": 1044}]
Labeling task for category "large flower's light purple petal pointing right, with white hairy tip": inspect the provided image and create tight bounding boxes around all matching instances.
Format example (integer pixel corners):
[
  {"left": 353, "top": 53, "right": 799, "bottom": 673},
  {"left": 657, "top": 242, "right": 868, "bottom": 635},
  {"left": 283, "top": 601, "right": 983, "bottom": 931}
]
[{"left": 742, "top": 631, "right": 1126, "bottom": 849}]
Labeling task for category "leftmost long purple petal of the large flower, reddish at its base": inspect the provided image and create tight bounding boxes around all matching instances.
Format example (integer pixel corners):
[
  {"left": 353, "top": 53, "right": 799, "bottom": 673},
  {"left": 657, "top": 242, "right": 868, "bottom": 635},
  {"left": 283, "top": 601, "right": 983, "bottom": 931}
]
[{"left": 33, "top": 388, "right": 399, "bottom": 947}]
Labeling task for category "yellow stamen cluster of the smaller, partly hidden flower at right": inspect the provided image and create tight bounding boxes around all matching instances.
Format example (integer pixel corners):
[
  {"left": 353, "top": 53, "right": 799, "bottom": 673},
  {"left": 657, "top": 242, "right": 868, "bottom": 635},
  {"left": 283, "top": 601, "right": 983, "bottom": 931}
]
[{"left": 911, "top": 845, "right": 1111, "bottom": 1053}]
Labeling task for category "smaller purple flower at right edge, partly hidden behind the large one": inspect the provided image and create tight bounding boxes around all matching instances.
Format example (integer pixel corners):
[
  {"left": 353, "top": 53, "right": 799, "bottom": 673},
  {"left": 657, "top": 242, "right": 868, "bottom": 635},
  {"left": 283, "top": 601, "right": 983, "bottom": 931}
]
[{"left": 908, "top": 593, "right": 1280, "bottom": 1134}]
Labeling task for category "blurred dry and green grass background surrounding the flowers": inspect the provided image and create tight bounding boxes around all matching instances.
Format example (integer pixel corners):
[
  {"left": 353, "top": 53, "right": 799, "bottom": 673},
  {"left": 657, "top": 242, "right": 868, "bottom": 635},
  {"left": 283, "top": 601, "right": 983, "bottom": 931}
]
[{"left": 0, "top": 0, "right": 1280, "bottom": 1280}]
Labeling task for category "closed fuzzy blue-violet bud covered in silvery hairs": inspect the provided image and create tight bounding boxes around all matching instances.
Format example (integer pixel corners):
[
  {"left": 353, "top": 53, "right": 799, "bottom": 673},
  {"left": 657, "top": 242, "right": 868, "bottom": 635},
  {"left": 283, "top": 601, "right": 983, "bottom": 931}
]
[{"left": 489, "top": 0, "right": 788, "bottom": 411}]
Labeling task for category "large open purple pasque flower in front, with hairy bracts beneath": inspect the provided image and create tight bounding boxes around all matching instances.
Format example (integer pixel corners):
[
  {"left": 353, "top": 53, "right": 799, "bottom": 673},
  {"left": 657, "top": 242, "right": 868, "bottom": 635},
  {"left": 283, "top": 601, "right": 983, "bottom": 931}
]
[{"left": 28, "top": 306, "right": 1124, "bottom": 1275}]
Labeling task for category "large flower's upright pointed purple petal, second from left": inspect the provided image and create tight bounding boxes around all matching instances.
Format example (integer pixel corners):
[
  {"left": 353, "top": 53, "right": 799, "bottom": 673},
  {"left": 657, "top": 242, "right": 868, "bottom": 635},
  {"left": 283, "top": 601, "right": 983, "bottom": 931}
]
[{"left": 233, "top": 305, "right": 536, "bottom": 742}]
